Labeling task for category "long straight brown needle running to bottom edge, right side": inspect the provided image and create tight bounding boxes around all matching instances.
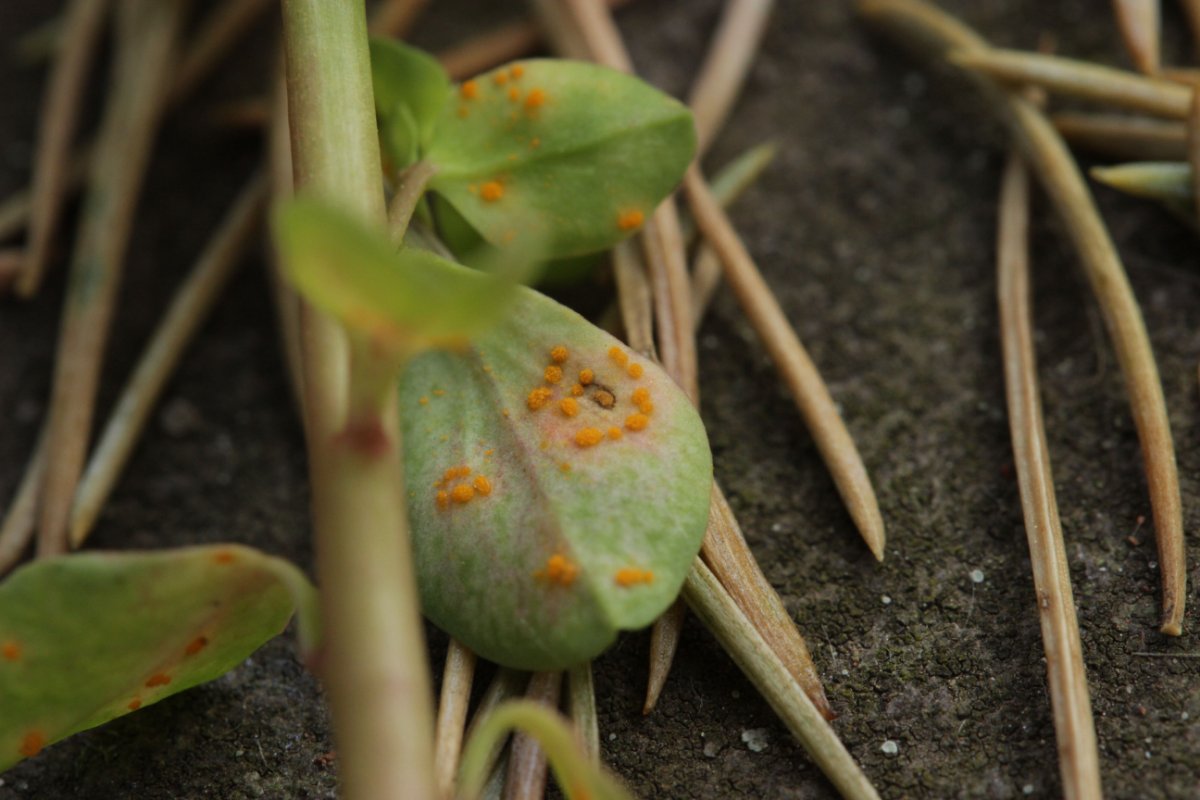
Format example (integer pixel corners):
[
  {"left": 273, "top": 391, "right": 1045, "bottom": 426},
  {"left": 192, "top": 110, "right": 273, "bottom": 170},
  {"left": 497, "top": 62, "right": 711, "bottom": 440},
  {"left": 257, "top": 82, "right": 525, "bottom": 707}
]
[{"left": 996, "top": 156, "right": 1100, "bottom": 800}]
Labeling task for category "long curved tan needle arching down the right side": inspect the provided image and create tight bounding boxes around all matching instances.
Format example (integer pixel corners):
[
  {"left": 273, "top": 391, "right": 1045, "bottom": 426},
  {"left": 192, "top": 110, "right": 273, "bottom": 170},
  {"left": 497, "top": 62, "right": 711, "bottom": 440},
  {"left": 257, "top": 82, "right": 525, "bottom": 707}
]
[{"left": 859, "top": 0, "right": 1190, "bottom": 636}]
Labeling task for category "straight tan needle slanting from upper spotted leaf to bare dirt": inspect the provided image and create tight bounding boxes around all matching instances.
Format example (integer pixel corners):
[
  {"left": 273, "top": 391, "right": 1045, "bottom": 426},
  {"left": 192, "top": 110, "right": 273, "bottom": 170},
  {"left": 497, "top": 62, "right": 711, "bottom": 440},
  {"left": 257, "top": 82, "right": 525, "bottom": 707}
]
[{"left": 684, "top": 168, "right": 886, "bottom": 560}]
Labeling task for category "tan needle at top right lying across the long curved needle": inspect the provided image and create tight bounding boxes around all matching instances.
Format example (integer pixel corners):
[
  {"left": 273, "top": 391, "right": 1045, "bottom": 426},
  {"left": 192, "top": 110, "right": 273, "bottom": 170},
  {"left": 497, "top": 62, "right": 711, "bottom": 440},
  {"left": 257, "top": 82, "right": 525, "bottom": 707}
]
[{"left": 948, "top": 48, "right": 1192, "bottom": 120}]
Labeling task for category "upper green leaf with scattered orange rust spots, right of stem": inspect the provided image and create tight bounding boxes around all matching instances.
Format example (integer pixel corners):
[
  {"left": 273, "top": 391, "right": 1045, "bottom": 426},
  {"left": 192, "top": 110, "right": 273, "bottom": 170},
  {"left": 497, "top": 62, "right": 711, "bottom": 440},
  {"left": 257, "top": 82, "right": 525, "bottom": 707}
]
[{"left": 424, "top": 60, "right": 696, "bottom": 258}]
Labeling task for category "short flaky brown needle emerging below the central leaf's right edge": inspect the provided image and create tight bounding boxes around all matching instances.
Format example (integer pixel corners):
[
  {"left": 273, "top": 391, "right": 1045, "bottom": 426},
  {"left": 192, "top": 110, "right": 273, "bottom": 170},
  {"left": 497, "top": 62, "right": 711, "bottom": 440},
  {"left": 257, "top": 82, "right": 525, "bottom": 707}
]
[{"left": 700, "top": 483, "right": 836, "bottom": 720}]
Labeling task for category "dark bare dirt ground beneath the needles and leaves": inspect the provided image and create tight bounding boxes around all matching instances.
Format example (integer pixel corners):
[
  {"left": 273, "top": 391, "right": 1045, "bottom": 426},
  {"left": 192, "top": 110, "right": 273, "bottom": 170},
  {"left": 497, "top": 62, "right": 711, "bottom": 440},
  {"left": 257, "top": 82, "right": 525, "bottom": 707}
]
[{"left": 0, "top": 0, "right": 1200, "bottom": 800}]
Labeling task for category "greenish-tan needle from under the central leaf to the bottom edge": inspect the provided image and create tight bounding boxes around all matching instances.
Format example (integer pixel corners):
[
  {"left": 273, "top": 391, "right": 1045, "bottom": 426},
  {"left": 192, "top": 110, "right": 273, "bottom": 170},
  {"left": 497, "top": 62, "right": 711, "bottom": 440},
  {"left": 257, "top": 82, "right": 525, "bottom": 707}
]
[{"left": 683, "top": 559, "right": 880, "bottom": 800}]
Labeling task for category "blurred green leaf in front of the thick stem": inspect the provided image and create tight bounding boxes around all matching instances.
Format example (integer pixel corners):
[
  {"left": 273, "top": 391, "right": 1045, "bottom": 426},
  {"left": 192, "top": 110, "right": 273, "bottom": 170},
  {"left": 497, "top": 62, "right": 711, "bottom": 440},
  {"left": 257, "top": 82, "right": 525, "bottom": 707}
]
[{"left": 275, "top": 198, "right": 536, "bottom": 354}]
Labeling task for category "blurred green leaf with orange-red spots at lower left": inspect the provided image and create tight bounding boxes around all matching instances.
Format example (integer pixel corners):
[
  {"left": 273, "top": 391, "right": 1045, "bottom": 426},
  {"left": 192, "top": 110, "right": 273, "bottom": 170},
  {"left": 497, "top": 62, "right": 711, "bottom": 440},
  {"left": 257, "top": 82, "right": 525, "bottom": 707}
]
[{"left": 0, "top": 545, "right": 317, "bottom": 770}]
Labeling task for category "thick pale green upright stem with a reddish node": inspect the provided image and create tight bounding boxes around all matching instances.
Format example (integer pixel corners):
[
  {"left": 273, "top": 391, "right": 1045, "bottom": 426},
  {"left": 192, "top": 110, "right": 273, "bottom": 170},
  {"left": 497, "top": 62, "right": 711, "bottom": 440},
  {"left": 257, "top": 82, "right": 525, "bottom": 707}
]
[{"left": 283, "top": 0, "right": 436, "bottom": 800}]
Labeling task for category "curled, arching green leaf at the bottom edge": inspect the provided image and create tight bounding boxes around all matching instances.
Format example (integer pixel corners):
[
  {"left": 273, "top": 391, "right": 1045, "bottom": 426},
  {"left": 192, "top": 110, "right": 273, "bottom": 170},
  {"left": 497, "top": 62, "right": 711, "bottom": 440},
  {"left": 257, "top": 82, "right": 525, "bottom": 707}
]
[{"left": 458, "top": 700, "right": 634, "bottom": 800}]
